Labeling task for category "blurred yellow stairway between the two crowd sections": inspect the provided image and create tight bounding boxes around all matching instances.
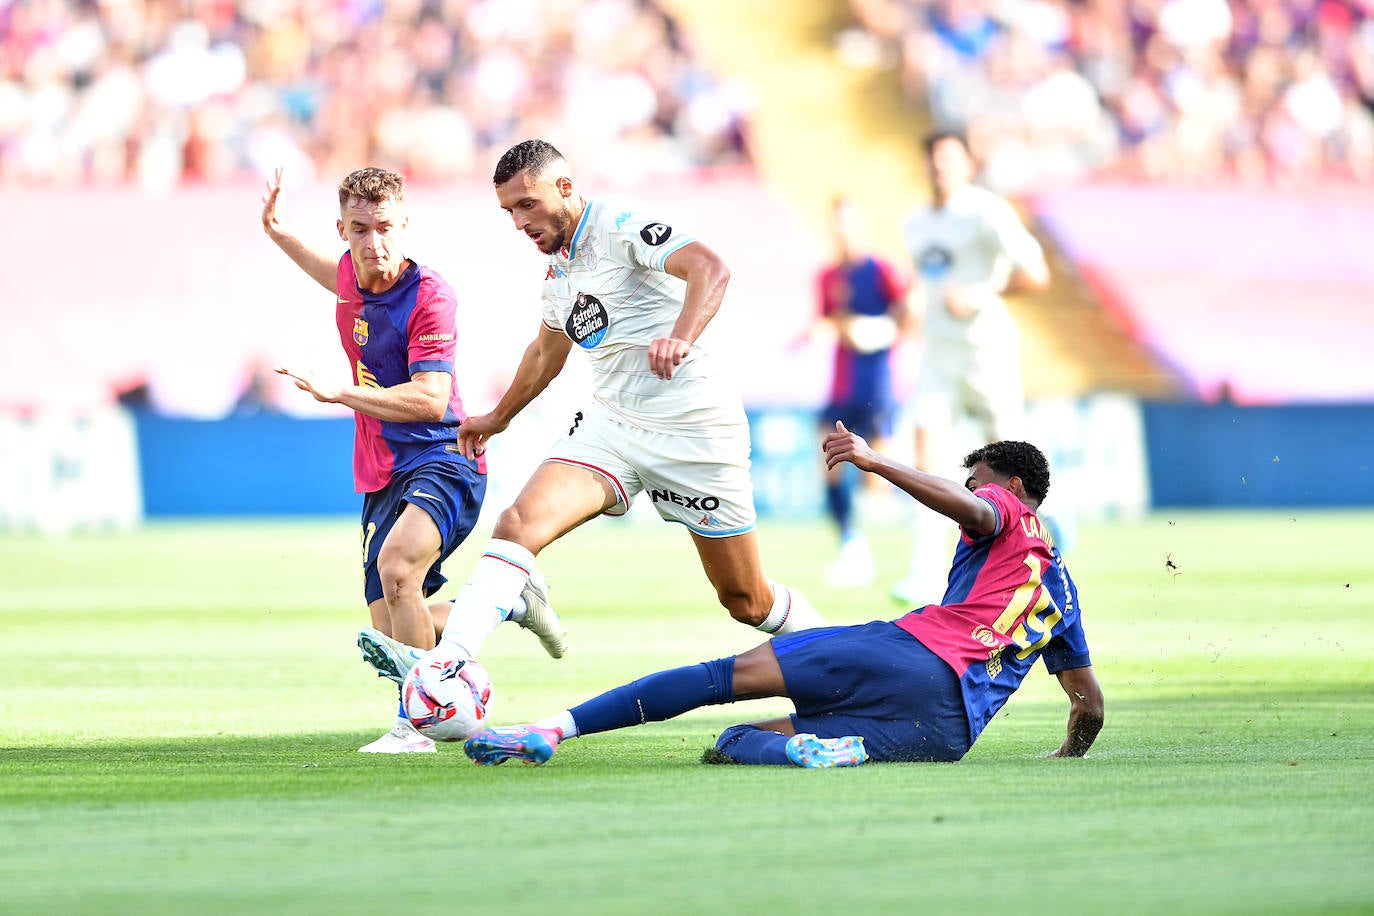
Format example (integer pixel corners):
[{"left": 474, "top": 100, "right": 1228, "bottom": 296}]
[{"left": 672, "top": 0, "right": 1183, "bottom": 398}]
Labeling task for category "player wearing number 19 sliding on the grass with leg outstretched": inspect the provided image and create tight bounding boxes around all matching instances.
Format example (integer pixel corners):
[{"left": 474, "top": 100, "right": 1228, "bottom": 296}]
[{"left": 464, "top": 433, "right": 1103, "bottom": 768}]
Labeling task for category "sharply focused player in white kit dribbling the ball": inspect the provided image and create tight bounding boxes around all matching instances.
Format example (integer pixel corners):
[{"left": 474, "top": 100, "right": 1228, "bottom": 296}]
[{"left": 364, "top": 140, "right": 824, "bottom": 677}]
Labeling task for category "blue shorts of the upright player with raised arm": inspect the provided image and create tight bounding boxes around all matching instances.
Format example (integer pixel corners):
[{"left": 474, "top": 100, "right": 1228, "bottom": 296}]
[{"left": 363, "top": 456, "right": 486, "bottom": 604}]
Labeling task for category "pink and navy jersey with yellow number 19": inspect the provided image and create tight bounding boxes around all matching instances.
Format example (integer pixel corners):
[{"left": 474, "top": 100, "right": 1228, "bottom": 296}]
[{"left": 896, "top": 483, "right": 1091, "bottom": 739}]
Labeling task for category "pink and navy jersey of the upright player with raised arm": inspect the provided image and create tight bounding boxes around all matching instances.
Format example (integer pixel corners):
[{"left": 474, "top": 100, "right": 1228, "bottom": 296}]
[{"left": 334, "top": 251, "right": 486, "bottom": 493}]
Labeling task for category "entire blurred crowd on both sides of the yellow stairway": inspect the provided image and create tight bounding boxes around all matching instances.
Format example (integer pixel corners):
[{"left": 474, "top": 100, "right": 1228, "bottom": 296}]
[{"left": 10, "top": 0, "right": 1374, "bottom": 192}]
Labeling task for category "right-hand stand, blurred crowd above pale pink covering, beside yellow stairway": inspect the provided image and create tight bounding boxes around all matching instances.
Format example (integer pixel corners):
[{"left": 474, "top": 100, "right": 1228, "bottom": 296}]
[{"left": 802, "top": 0, "right": 1374, "bottom": 402}]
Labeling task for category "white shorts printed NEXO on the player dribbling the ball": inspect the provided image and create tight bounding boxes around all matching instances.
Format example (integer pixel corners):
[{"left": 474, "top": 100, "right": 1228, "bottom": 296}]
[{"left": 544, "top": 404, "right": 757, "bottom": 537}]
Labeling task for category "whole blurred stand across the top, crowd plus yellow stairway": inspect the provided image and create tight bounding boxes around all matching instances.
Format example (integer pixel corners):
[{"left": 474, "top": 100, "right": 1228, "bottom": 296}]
[{"left": 8, "top": 0, "right": 1374, "bottom": 409}]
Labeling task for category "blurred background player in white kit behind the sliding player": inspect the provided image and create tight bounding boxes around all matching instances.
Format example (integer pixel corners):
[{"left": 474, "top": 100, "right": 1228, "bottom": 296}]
[{"left": 892, "top": 132, "right": 1050, "bottom": 606}]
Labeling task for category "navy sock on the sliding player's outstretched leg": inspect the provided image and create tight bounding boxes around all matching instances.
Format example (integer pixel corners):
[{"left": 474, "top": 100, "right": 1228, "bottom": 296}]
[{"left": 569, "top": 656, "right": 735, "bottom": 735}]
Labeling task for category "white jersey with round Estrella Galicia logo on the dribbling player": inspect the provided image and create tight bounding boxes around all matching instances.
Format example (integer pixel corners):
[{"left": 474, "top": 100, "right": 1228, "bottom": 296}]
[{"left": 543, "top": 196, "right": 746, "bottom": 438}]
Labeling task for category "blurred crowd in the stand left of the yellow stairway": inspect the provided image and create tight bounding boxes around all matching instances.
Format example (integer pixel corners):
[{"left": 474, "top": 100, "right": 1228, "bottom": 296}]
[{"left": 0, "top": 0, "right": 749, "bottom": 188}]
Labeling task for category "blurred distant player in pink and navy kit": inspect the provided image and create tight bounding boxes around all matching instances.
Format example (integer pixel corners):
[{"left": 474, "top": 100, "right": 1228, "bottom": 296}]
[{"left": 808, "top": 198, "right": 907, "bottom": 588}]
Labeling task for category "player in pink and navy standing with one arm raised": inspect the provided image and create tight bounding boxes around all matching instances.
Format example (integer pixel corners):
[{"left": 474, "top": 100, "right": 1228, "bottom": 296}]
[{"left": 262, "top": 169, "right": 486, "bottom": 754}]
